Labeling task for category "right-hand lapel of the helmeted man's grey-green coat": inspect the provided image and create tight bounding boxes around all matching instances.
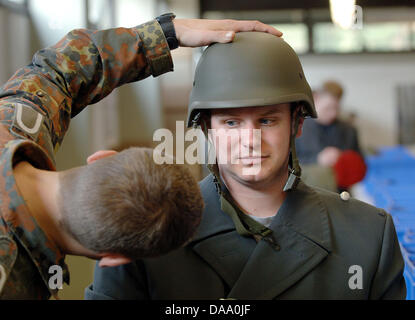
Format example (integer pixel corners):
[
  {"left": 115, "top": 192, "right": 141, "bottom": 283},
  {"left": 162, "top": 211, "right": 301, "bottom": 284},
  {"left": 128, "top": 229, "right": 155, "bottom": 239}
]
[{"left": 228, "top": 183, "right": 331, "bottom": 299}]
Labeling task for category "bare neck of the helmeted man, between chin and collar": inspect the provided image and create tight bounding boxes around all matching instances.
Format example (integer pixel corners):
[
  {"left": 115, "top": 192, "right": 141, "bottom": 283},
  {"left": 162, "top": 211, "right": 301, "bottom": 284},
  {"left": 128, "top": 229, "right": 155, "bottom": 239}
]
[{"left": 222, "top": 173, "right": 288, "bottom": 217}]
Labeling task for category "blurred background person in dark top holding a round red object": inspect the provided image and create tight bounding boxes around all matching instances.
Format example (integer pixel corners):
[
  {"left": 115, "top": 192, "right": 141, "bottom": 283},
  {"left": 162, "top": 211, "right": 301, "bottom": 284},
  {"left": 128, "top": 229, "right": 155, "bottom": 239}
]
[{"left": 296, "top": 80, "right": 366, "bottom": 191}]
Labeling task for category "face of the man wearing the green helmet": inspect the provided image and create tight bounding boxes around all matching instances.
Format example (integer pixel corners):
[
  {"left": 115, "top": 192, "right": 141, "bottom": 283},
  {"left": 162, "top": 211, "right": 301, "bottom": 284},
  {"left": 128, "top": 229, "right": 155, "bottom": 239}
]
[{"left": 209, "top": 103, "right": 301, "bottom": 184}]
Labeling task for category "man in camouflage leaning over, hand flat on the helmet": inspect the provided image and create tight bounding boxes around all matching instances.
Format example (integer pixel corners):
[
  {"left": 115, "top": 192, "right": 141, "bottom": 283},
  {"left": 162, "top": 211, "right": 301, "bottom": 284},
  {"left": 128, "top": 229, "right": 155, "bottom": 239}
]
[{"left": 0, "top": 14, "right": 281, "bottom": 299}]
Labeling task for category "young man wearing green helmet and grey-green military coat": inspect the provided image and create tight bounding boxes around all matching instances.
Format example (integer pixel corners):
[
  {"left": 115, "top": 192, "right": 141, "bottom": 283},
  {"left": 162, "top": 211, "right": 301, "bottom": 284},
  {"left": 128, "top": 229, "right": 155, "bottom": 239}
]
[{"left": 86, "top": 33, "right": 406, "bottom": 299}]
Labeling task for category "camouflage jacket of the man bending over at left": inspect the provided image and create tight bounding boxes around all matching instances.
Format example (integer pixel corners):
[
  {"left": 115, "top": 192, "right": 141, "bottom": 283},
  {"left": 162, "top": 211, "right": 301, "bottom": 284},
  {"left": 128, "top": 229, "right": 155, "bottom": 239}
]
[{"left": 0, "top": 21, "right": 173, "bottom": 299}]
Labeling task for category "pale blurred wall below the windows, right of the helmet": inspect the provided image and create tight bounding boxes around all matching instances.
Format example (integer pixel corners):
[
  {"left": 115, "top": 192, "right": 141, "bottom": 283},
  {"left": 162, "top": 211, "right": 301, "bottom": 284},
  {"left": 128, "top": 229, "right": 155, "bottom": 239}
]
[{"left": 300, "top": 54, "right": 415, "bottom": 148}]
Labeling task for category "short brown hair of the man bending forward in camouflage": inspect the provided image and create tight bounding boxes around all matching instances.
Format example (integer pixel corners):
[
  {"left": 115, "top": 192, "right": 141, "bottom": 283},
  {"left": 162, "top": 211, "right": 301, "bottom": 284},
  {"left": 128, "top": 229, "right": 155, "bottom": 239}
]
[{"left": 60, "top": 148, "right": 203, "bottom": 259}]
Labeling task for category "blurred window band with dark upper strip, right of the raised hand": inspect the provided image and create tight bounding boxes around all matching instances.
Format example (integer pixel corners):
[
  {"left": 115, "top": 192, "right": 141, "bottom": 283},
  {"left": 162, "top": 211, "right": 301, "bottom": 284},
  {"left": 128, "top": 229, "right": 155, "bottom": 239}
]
[{"left": 203, "top": 7, "right": 415, "bottom": 54}]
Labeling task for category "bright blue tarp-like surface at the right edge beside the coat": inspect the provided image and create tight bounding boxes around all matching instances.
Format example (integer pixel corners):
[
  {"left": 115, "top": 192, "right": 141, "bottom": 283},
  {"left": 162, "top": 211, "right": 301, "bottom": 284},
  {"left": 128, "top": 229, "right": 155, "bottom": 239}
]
[{"left": 362, "top": 146, "right": 415, "bottom": 300}]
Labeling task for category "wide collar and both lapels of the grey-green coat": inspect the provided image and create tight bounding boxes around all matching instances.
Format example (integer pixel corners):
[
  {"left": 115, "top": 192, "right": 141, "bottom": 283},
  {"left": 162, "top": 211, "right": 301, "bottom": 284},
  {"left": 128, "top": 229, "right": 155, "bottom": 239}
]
[{"left": 193, "top": 176, "right": 332, "bottom": 299}]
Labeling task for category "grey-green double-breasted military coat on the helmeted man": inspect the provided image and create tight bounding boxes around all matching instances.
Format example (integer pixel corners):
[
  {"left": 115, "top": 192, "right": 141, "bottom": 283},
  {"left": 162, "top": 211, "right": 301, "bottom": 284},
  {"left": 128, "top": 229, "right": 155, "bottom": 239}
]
[{"left": 85, "top": 176, "right": 406, "bottom": 299}]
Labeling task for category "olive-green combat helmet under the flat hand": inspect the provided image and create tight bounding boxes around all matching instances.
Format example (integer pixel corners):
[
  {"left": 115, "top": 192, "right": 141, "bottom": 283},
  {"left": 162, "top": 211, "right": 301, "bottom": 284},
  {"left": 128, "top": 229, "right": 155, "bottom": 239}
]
[{"left": 187, "top": 32, "right": 317, "bottom": 127}]
